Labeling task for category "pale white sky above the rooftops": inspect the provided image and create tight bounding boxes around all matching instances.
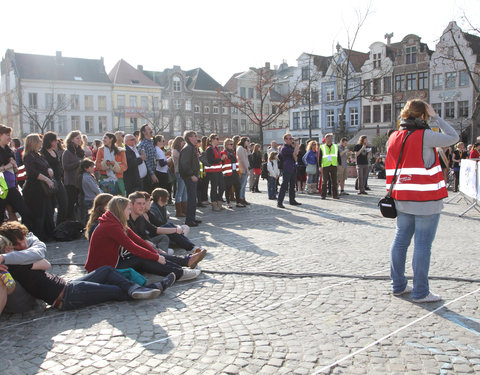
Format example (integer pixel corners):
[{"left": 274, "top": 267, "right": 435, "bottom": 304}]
[{"left": 0, "top": 0, "right": 480, "bottom": 84}]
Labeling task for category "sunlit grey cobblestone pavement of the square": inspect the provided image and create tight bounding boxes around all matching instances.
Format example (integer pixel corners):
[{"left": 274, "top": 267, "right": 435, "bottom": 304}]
[{"left": 0, "top": 179, "right": 480, "bottom": 375}]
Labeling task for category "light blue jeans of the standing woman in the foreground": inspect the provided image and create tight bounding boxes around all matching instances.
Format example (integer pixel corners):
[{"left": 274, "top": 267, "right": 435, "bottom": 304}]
[{"left": 390, "top": 212, "right": 440, "bottom": 299}]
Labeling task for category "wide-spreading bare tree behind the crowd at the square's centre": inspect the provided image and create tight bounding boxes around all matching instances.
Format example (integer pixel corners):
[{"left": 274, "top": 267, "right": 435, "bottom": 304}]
[{"left": 219, "top": 67, "right": 300, "bottom": 145}]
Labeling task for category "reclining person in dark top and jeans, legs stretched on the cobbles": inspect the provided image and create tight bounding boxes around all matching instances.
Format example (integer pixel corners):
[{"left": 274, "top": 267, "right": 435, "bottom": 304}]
[{"left": 0, "top": 223, "right": 175, "bottom": 310}]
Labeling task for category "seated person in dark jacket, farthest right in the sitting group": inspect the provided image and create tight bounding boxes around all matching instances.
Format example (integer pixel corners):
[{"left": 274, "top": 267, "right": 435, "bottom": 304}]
[{"left": 145, "top": 188, "right": 207, "bottom": 254}]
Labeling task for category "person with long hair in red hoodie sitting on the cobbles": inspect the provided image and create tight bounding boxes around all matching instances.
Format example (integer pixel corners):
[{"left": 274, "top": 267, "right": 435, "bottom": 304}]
[{"left": 85, "top": 196, "right": 203, "bottom": 281}]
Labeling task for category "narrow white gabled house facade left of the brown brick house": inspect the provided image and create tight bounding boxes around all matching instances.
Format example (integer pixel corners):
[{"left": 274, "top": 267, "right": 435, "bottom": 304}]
[{"left": 362, "top": 42, "right": 393, "bottom": 128}]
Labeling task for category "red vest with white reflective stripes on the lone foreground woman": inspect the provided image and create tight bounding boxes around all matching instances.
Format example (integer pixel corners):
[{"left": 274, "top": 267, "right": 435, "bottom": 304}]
[{"left": 385, "top": 130, "right": 448, "bottom": 202}]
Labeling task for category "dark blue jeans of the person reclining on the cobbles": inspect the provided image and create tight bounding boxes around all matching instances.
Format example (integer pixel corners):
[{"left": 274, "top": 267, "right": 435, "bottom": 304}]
[{"left": 62, "top": 266, "right": 136, "bottom": 310}]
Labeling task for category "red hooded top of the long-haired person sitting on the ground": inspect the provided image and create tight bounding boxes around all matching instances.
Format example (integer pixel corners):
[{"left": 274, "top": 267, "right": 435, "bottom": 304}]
[{"left": 85, "top": 211, "right": 159, "bottom": 272}]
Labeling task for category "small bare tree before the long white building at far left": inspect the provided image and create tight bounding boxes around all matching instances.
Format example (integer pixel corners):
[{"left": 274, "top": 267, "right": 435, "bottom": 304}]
[{"left": 15, "top": 88, "right": 70, "bottom": 134}]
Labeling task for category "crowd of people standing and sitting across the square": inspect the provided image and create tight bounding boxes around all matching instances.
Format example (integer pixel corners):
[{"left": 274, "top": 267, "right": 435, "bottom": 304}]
[{"left": 0, "top": 103, "right": 480, "bottom": 311}]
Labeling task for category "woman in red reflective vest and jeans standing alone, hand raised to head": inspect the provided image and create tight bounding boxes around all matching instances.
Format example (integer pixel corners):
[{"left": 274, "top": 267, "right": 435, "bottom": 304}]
[{"left": 385, "top": 99, "right": 458, "bottom": 303}]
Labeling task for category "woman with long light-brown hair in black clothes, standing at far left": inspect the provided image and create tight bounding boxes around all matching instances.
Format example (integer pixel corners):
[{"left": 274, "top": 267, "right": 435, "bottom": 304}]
[{"left": 23, "top": 133, "right": 55, "bottom": 242}]
